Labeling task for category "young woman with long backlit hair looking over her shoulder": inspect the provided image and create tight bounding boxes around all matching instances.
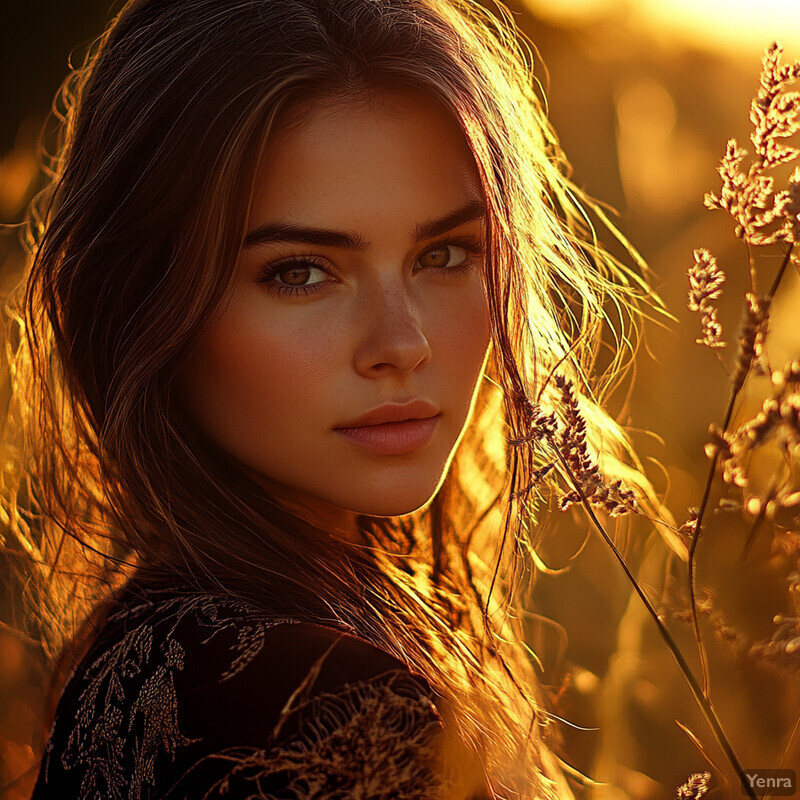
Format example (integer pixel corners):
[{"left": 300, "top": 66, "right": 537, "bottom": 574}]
[{"left": 3, "top": 0, "right": 656, "bottom": 798}]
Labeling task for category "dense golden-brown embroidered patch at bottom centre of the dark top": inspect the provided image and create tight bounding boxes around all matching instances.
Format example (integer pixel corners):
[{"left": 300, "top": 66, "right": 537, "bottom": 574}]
[{"left": 198, "top": 670, "right": 449, "bottom": 800}]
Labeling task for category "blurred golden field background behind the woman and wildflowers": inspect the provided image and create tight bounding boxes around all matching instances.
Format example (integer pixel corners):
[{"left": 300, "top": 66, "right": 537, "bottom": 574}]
[{"left": 0, "top": 0, "right": 800, "bottom": 800}]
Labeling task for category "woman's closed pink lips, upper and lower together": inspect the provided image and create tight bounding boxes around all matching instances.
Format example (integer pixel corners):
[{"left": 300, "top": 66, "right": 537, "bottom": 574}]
[{"left": 334, "top": 400, "right": 441, "bottom": 455}]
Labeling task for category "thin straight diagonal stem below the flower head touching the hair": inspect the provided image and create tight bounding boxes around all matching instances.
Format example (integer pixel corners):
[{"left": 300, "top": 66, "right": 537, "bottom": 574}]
[{"left": 557, "top": 452, "right": 758, "bottom": 800}]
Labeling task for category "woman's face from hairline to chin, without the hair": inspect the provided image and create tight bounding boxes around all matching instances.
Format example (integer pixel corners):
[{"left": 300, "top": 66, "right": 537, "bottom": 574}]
[{"left": 179, "top": 89, "right": 489, "bottom": 529}]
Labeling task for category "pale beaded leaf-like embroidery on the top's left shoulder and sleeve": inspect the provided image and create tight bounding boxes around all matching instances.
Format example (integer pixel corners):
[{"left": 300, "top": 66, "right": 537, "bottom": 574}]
[{"left": 46, "top": 595, "right": 304, "bottom": 800}]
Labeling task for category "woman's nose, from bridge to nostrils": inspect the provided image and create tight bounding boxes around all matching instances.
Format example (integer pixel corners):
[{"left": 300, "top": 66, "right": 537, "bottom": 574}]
[{"left": 355, "top": 283, "right": 431, "bottom": 378}]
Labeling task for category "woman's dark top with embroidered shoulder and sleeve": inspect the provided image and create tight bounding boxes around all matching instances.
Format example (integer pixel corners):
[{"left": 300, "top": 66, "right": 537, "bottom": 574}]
[{"left": 32, "top": 589, "right": 486, "bottom": 800}]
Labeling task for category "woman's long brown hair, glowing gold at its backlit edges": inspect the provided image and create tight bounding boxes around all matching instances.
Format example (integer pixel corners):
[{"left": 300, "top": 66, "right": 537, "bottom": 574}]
[{"left": 5, "top": 0, "right": 660, "bottom": 797}]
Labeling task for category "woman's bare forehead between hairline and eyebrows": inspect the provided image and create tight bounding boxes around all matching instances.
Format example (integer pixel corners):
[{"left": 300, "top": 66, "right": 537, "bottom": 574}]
[{"left": 251, "top": 89, "right": 482, "bottom": 228}]
